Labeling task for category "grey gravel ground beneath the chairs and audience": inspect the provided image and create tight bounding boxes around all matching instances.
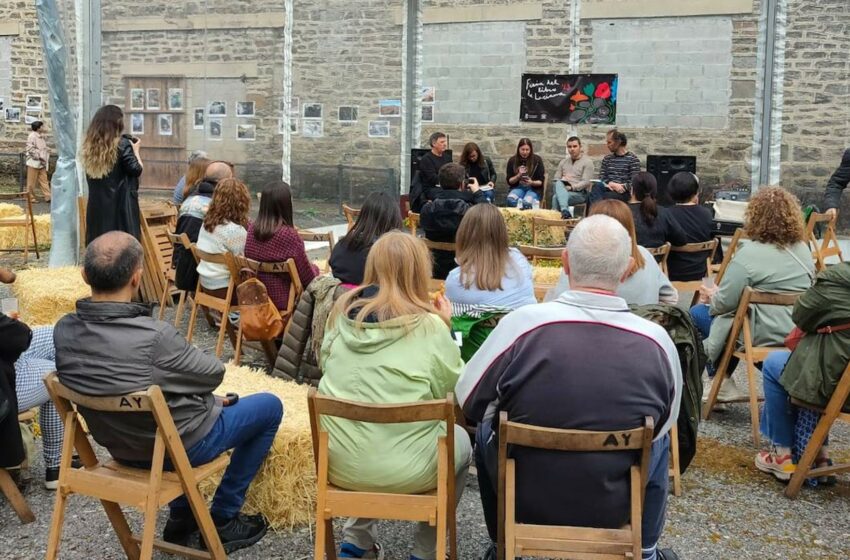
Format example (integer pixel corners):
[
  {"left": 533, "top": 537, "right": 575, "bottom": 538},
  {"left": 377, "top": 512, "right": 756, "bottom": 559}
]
[{"left": 0, "top": 254, "right": 850, "bottom": 560}]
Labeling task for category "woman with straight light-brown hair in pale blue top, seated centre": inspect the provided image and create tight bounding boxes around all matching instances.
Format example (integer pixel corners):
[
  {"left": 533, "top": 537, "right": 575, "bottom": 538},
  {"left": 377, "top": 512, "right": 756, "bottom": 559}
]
[{"left": 446, "top": 204, "right": 537, "bottom": 310}]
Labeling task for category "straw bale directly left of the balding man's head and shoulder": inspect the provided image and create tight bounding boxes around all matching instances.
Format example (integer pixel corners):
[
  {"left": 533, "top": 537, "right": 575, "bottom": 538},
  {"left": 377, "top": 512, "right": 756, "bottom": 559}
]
[{"left": 12, "top": 266, "right": 91, "bottom": 327}]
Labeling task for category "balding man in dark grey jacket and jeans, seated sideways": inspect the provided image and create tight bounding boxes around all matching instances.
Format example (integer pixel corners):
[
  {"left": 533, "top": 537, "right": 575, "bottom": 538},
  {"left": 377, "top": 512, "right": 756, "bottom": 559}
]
[{"left": 53, "top": 231, "right": 283, "bottom": 552}]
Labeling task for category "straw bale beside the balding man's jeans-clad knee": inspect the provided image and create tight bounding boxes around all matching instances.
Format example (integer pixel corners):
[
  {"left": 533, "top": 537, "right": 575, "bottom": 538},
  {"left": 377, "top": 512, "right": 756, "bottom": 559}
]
[{"left": 202, "top": 363, "right": 316, "bottom": 529}]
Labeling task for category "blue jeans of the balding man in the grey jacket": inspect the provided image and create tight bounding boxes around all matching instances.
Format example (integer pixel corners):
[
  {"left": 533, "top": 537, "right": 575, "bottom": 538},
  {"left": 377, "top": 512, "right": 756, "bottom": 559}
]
[{"left": 169, "top": 393, "right": 283, "bottom": 519}]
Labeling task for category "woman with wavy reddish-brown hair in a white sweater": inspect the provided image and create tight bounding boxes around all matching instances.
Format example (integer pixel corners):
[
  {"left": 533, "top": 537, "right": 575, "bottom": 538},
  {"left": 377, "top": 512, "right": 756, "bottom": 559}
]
[{"left": 197, "top": 179, "right": 251, "bottom": 300}]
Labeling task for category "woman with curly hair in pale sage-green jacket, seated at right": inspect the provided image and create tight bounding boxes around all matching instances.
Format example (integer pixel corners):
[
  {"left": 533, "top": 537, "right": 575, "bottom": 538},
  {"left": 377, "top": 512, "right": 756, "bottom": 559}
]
[{"left": 691, "top": 187, "right": 815, "bottom": 402}]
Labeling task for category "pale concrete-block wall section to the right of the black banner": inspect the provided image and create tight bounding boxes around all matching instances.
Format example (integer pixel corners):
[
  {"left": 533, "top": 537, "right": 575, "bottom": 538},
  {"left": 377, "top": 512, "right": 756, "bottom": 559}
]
[{"left": 592, "top": 16, "right": 732, "bottom": 129}]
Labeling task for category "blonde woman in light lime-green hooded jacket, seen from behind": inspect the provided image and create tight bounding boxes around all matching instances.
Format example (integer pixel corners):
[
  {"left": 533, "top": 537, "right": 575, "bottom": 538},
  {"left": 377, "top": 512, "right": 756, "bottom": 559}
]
[{"left": 319, "top": 231, "right": 472, "bottom": 560}]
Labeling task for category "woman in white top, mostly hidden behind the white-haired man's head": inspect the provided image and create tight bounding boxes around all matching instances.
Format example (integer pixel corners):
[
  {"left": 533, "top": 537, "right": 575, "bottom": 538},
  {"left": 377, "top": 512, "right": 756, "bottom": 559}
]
[{"left": 546, "top": 199, "right": 679, "bottom": 305}]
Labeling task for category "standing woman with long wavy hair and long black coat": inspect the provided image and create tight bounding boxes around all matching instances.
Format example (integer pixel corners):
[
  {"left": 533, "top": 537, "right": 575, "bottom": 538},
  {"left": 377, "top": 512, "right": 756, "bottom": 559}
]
[{"left": 80, "top": 105, "right": 143, "bottom": 245}]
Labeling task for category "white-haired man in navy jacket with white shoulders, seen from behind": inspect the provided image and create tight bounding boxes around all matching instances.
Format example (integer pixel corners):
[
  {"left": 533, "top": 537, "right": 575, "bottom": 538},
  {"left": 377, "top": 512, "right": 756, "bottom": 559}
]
[{"left": 455, "top": 215, "right": 682, "bottom": 560}]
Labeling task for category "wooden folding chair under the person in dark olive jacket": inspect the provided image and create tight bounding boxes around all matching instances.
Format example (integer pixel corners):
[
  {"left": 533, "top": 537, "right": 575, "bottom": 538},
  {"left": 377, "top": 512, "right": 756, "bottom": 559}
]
[{"left": 785, "top": 364, "right": 850, "bottom": 499}]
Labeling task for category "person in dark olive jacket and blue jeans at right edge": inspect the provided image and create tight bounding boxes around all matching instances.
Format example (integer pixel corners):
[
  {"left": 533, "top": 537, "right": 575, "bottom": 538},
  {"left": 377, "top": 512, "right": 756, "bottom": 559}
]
[{"left": 755, "top": 263, "right": 850, "bottom": 483}]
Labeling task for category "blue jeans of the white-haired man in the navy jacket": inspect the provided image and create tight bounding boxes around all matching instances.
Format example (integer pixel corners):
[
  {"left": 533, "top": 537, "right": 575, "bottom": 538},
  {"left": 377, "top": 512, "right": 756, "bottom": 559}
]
[{"left": 475, "top": 422, "right": 670, "bottom": 560}]
